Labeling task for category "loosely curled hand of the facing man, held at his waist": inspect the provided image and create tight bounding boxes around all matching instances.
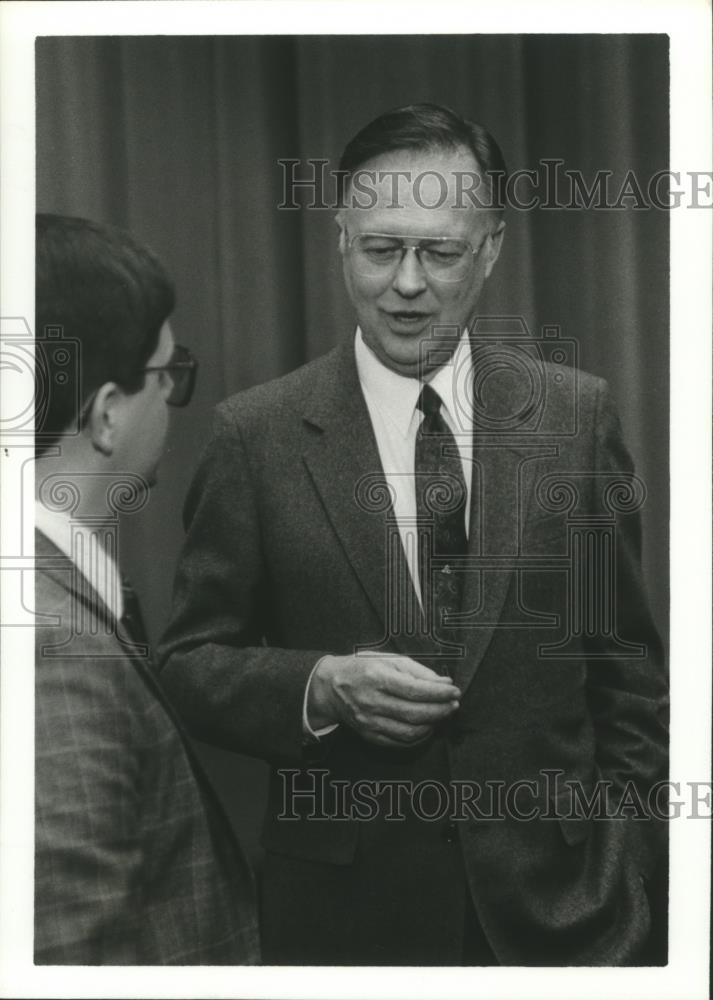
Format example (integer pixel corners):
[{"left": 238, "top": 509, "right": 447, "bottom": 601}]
[{"left": 307, "top": 653, "right": 460, "bottom": 747}]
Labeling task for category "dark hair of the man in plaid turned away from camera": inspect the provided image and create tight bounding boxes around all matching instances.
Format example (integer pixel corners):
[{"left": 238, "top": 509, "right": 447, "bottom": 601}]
[{"left": 35, "top": 214, "right": 176, "bottom": 454}]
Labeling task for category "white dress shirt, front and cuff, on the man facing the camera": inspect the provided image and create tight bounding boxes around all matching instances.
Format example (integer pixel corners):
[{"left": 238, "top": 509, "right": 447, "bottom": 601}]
[{"left": 302, "top": 327, "right": 473, "bottom": 737}]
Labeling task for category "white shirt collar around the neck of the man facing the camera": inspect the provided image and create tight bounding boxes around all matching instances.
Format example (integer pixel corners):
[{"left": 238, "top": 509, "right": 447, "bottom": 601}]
[{"left": 354, "top": 327, "right": 473, "bottom": 438}]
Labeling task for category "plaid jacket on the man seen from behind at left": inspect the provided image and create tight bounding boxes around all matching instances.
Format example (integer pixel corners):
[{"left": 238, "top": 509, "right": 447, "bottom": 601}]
[{"left": 35, "top": 532, "right": 259, "bottom": 965}]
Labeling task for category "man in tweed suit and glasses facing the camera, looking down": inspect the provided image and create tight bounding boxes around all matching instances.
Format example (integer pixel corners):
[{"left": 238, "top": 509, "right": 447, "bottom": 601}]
[{"left": 162, "top": 105, "right": 667, "bottom": 965}]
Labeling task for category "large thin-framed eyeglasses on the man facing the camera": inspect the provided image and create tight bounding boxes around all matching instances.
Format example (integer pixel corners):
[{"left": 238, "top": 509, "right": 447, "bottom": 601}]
[{"left": 340, "top": 233, "right": 490, "bottom": 281}]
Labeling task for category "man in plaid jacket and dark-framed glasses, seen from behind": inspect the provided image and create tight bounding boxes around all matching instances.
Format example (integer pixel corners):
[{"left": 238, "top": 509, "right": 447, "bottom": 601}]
[{"left": 35, "top": 215, "right": 258, "bottom": 965}]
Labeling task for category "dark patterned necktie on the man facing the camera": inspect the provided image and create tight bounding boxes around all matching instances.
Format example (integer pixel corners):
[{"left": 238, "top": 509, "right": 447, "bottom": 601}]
[{"left": 414, "top": 385, "right": 468, "bottom": 666}]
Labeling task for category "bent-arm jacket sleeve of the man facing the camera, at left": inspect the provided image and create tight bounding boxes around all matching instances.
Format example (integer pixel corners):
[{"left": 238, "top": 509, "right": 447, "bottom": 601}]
[{"left": 159, "top": 409, "right": 328, "bottom": 763}]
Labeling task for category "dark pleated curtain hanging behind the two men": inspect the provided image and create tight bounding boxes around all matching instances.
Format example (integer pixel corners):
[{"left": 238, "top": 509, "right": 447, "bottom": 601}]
[{"left": 36, "top": 33, "right": 668, "bottom": 860}]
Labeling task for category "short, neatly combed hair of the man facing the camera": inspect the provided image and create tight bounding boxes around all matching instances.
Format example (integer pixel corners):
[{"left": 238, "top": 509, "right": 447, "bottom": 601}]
[{"left": 339, "top": 104, "right": 507, "bottom": 212}]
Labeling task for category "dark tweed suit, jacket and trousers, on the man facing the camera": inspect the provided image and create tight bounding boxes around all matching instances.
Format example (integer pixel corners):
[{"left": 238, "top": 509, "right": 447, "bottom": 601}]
[{"left": 161, "top": 332, "right": 667, "bottom": 965}]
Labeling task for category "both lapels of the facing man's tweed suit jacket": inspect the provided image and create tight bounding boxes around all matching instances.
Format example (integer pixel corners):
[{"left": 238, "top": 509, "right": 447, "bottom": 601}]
[{"left": 303, "top": 340, "right": 536, "bottom": 672}]
